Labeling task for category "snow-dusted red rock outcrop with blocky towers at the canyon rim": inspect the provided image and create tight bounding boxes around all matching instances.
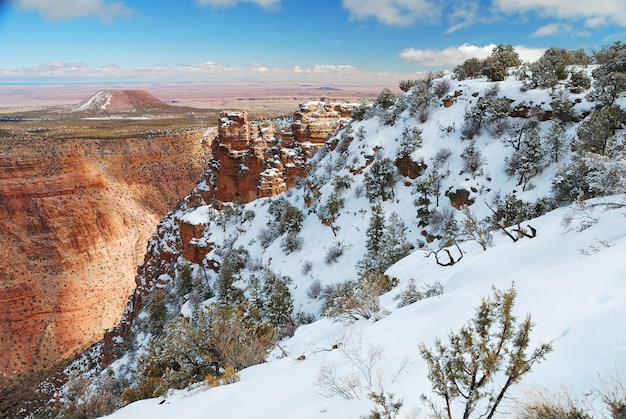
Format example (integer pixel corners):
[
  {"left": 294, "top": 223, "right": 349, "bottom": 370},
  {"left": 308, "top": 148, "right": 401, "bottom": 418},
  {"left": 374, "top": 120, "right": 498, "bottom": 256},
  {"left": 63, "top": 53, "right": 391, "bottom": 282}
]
[{"left": 203, "top": 102, "right": 352, "bottom": 202}]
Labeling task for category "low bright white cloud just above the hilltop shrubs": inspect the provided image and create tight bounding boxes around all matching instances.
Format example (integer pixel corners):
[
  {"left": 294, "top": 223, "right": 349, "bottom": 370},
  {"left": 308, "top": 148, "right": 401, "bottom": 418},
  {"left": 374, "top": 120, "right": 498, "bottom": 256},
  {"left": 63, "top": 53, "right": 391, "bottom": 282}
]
[{"left": 400, "top": 44, "right": 545, "bottom": 67}]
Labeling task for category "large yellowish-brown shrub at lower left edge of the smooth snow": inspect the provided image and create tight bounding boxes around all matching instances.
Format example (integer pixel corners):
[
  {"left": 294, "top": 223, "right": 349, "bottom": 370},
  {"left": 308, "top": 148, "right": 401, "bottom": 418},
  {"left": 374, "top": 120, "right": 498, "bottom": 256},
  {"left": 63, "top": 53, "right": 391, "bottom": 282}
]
[{"left": 139, "top": 302, "right": 275, "bottom": 399}]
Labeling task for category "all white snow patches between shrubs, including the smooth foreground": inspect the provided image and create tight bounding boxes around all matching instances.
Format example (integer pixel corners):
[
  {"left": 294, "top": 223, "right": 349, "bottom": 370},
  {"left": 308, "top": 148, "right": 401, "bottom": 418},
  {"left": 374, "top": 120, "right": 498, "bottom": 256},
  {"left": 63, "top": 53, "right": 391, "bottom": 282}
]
[{"left": 88, "top": 69, "right": 626, "bottom": 419}]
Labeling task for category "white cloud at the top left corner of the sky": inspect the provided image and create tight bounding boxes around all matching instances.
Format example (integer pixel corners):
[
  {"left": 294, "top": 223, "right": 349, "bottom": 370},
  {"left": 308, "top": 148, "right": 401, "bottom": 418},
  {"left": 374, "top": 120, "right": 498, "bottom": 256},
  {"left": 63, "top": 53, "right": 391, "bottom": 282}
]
[{"left": 12, "top": 0, "right": 134, "bottom": 22}]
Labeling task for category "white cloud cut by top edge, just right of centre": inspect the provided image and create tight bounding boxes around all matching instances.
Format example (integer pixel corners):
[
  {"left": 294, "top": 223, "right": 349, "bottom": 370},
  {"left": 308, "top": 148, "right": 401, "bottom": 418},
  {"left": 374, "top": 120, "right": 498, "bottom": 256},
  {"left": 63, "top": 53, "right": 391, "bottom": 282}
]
[{"left": 343, "top": 0, "right": 442, "bottom": 26}]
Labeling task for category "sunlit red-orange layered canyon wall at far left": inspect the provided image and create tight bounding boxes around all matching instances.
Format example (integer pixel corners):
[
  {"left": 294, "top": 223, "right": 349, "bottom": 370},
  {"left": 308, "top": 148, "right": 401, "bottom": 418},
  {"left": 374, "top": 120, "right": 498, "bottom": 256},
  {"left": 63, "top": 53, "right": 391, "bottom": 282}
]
[{"left": 0, "top": 132, "right": 202, "bottom": 390}]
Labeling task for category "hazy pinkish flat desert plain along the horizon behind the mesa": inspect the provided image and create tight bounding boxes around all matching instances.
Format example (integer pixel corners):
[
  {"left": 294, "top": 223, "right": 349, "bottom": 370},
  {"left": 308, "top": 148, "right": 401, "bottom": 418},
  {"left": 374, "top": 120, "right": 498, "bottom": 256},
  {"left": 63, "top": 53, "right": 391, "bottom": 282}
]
[{"left": 0, "top": 82, "right": 390, "bottom": 115}]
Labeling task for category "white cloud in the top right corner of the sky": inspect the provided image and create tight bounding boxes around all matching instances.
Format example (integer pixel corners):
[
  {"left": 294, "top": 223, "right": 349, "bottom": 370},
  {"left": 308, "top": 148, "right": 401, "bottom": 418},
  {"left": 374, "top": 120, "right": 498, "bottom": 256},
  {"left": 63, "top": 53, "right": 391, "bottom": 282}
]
[{"left": 493, "top": 0, "right": 626, "bottom": 28}]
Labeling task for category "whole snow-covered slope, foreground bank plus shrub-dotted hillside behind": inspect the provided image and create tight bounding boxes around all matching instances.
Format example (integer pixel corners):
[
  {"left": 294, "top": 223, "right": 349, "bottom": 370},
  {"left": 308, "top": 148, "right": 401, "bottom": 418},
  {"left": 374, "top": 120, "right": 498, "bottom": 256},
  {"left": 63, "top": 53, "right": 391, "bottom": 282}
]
[{"left": 50, "top": 64, "right": 626, "bottom": 418}]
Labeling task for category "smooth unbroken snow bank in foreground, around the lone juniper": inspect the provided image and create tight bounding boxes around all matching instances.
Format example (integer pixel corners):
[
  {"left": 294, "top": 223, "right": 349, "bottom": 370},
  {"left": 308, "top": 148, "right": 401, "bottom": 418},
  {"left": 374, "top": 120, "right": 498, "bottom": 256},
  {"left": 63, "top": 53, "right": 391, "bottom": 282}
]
[{"left": 105, "top": 201, "right": 626, "bottom": 419}]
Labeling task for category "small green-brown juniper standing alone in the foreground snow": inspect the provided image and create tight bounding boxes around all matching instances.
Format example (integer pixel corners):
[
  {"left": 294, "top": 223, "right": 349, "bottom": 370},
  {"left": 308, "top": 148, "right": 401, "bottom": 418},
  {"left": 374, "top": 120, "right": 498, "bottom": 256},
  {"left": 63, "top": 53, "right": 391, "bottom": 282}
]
[{"left": 419, "top": 286, "right": 552, "bottom": 419}]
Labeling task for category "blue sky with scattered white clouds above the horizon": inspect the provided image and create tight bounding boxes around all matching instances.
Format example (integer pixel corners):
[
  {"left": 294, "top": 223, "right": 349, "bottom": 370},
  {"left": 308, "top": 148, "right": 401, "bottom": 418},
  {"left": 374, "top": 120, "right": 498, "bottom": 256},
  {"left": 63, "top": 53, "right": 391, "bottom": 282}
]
[{"left": 0, "top": 0, "right": 626, "bottom": 84}]
